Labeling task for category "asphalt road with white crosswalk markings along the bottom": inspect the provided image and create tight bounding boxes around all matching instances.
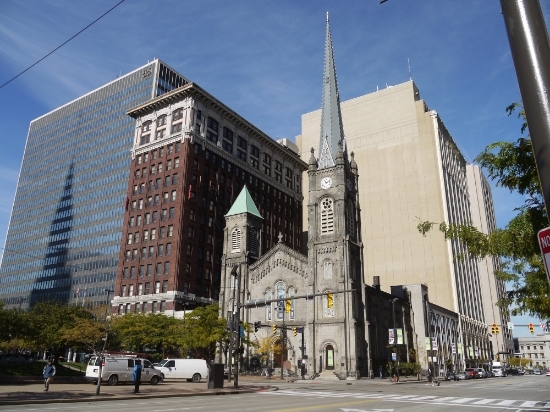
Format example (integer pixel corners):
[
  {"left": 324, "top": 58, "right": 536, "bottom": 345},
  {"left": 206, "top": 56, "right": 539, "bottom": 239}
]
[{"left": 2, "top": 376, "right": 550, "bottom": 412}]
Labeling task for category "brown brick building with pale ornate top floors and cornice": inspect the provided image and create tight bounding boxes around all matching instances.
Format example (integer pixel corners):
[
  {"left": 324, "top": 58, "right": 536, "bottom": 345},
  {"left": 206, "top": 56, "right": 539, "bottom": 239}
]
[{"left": 113, "top": 83, "right": 307, "bottom": 316}]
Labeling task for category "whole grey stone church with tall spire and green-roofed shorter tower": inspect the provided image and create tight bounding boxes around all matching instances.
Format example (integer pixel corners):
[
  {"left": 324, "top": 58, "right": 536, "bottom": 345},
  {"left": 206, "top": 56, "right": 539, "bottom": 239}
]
[{"left": 220, "top": 16, "right": 367, "bottom": 379}]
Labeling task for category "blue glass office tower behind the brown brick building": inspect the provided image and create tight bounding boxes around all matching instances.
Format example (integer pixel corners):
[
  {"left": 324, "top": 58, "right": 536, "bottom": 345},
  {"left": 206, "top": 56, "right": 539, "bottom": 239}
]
[{"left": 0, "top": 60, "right": 187, "bottom": 307}]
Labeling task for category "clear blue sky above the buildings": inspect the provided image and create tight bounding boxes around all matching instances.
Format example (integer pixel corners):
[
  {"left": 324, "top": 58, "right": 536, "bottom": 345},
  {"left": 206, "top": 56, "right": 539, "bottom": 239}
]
[{"left": 0, "top": 0, "right": 550, "bottom": 336}]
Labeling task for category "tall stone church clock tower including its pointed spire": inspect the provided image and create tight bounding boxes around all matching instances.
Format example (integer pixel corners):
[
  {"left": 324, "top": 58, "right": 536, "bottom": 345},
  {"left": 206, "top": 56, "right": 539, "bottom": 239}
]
[{"left": 308, "top": 13, "right": 367, "bottom": 378}]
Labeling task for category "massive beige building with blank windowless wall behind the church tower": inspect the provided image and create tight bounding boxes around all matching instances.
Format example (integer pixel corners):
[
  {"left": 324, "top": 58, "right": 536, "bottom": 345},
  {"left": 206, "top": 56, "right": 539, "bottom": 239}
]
[{"left": 296, "top": 81, "right": 491, "bottom": 365}]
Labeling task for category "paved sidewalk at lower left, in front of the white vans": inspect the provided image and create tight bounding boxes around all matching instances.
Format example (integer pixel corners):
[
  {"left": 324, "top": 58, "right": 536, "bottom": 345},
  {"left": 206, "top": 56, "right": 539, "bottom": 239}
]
[{"left": 0, "top": 379, "right": 276, "bottom": 405}]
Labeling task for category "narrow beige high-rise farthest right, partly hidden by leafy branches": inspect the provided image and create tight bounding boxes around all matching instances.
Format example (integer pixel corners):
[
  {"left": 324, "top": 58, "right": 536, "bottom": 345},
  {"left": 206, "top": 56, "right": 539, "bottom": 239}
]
[{"left": 466, "top": 165, "right": 514, "bottom": 354}]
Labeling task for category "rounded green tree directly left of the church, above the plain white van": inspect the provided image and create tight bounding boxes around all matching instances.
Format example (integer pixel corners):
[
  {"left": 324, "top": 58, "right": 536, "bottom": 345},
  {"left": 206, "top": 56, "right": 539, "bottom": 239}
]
[{"left": 183, "top": 304, "right": 228, "bottom": 360}]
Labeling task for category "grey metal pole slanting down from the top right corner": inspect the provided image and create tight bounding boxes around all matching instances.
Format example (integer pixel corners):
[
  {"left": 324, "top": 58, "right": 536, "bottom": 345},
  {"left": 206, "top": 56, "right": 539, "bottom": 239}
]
[{"left": 500, "top": 0, "right": 550, "bottom": 219}]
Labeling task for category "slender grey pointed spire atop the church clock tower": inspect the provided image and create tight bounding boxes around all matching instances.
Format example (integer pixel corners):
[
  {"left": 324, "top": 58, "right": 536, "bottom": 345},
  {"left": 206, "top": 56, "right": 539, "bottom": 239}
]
[{"left": 319, "top": 12, "right": 346, "bottom": 169}]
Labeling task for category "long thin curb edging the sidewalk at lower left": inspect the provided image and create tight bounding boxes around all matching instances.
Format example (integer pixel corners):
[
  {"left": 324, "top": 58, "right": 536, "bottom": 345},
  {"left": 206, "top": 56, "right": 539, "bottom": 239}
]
[{"left": 0, "top": 387, "right": 279, "bottom": 406}]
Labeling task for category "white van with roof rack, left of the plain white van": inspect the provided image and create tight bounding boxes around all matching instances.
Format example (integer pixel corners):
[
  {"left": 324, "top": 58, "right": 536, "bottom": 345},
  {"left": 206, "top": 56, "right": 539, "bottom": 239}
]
[{"left": 86, "top": 355, "right": 162, "bottom": 385}]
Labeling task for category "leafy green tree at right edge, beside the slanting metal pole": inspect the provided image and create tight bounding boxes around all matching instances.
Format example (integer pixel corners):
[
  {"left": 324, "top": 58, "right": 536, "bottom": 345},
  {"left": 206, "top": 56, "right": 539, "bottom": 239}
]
[{"left": 418, "top": 103, "right": 550, "bottom": 319}]
